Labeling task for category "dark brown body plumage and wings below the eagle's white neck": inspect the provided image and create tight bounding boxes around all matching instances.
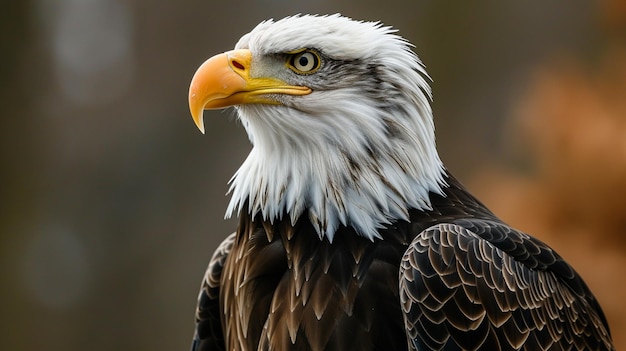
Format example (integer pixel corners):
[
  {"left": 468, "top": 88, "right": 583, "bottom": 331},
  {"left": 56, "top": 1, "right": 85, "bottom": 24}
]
[{"left": 193, "top": 177, "right": 613, "bottom": 351}]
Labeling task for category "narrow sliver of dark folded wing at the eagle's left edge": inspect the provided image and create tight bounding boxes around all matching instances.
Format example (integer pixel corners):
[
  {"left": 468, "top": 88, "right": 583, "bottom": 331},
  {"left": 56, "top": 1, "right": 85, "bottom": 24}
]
[{"left": 191, "top": 233, "right": 235, "bottom": 351}]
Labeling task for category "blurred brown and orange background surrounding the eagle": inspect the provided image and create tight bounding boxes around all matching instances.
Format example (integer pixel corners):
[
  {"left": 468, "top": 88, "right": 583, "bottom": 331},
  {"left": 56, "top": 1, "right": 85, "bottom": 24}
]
[{"left": 0, "top": 0, "right": 626, "bottom": 351}]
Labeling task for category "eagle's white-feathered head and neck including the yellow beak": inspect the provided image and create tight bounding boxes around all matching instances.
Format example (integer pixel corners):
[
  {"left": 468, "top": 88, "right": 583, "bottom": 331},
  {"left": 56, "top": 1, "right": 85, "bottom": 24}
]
[{"left": 189, "top": 15, "right": 445, "bottom": 241}]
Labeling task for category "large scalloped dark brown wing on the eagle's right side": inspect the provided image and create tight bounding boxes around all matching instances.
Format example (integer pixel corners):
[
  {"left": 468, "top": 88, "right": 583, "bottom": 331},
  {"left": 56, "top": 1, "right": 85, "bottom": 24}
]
[{"left": 400, "top": 223, "right": 614, "bottom": 350}]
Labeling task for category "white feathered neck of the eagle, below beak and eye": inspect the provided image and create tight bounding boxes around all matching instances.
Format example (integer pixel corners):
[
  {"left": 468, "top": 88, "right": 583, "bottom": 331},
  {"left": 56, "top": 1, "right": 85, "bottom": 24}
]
[{"left": 226, "top": 102, "right": 445, "bottom": 241}]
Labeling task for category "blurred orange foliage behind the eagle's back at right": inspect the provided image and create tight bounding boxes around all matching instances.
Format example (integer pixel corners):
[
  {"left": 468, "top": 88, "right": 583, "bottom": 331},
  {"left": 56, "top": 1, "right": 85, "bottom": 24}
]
[{"left": 471, "top": 47, "right": 626, "bottom": 349}]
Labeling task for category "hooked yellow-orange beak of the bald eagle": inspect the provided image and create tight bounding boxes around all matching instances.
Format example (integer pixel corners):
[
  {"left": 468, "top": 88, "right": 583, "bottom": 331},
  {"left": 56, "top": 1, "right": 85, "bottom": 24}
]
[{"left": 189, "top": 50, "right": 311, "bottom": 133}]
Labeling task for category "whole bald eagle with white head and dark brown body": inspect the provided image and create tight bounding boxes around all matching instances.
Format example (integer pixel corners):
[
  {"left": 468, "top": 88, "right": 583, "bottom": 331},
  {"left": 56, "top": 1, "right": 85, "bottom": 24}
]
[{"left": 189, "top": 15, "right": 614, "bottom": 351}]
